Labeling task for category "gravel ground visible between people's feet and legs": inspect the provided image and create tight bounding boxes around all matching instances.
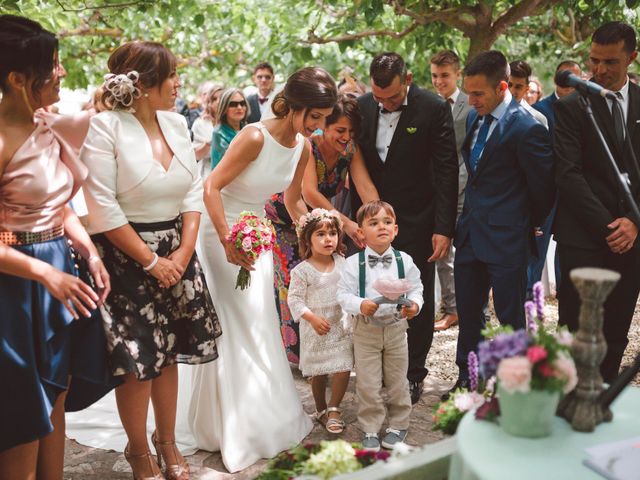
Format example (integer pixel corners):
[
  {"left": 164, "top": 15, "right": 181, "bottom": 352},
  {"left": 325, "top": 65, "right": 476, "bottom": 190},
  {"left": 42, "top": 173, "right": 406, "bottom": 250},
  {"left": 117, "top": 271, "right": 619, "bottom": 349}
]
[{"left": 64, "top": 299, "right": 640, "bottom": 480}]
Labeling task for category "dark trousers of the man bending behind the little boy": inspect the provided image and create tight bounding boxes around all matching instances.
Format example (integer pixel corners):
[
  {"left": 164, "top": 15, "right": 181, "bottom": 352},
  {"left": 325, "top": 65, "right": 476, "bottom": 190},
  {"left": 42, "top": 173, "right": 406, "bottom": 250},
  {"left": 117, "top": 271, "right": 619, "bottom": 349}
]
[{"left": 404, "top": 249, "right": 435, "bottom": 382}]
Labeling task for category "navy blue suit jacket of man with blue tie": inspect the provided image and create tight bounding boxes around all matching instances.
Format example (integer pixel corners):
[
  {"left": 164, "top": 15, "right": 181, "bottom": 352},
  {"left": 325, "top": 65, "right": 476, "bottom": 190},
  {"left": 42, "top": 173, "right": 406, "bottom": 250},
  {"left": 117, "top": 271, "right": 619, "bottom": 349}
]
[{"left": 454, "top": 100, "right": 555, "bottom": 265}]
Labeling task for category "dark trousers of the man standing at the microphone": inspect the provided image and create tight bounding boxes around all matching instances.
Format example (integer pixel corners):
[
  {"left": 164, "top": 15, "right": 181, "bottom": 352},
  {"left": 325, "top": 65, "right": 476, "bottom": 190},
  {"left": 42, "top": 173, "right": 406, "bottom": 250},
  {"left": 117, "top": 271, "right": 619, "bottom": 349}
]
[{"left": 558, "top": 244, "right": 640, "bottom": 383}]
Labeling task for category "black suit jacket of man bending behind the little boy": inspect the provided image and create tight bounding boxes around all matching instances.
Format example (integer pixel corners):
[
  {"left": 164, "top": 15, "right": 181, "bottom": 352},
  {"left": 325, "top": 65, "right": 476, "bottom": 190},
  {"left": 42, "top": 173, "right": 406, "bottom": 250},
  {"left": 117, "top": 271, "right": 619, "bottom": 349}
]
[{"left": 358, "top": 85, "right": 458, "bottom": 260}]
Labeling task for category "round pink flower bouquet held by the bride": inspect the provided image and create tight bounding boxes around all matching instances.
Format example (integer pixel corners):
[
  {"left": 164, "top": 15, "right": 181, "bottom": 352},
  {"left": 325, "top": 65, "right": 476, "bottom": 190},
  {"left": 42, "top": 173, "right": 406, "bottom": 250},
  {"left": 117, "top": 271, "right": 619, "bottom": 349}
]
[{"left": 229, "top": 211, "right": 276, "bottom": 290}]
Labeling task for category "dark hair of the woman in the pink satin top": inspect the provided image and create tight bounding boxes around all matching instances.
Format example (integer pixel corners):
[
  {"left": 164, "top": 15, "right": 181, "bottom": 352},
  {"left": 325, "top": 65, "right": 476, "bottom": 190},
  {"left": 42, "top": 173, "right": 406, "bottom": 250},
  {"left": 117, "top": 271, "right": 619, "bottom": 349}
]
[{"left": 0, "top": 15, "right": 58, "bottom": 97}]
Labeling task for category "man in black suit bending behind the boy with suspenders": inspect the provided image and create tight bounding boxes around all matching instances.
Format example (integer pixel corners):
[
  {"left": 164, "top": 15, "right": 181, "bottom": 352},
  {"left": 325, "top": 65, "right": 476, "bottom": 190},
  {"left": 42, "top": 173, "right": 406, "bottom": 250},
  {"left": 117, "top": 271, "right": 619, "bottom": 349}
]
[{"left": 358, "top": 53, "right": 458, "bottom": 403}]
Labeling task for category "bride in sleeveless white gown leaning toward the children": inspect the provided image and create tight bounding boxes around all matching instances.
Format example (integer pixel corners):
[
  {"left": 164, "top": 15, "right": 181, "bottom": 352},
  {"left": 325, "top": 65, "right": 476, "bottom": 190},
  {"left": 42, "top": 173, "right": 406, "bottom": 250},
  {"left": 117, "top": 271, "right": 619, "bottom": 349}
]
[{"left": 188, "top": 67, "right": 336, "bottom": 472}]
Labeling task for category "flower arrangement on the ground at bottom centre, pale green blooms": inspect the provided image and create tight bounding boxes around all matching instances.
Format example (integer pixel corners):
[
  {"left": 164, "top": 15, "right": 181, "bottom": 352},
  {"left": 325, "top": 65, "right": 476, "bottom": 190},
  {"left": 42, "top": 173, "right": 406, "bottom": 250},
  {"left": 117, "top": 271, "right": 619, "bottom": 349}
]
[{"left": 257, "top": 440, "right": 390, "bottom": 480}]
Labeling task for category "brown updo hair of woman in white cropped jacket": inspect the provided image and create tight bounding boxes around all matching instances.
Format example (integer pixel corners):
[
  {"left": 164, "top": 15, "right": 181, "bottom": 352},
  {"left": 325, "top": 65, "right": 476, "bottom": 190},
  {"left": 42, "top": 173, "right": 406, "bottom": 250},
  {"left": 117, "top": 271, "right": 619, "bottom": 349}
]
[{"left": 102, "top": 41, "right": 177, "bottom": 110}]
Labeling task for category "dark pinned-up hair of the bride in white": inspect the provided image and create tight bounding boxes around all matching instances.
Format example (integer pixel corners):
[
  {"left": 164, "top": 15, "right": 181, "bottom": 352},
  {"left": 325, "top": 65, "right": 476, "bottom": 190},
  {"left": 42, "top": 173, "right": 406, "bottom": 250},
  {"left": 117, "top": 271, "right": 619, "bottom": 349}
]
[{"left": 271, "top": 67, "right": 338, "bottom": 118}]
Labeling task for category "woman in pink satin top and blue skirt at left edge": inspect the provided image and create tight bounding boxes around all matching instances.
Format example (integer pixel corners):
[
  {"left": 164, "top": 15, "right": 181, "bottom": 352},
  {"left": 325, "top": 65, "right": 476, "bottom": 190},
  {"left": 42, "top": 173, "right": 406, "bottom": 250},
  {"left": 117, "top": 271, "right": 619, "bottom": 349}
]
[{"left": 0, "top": 15, "right": 110, "bottom": 479}]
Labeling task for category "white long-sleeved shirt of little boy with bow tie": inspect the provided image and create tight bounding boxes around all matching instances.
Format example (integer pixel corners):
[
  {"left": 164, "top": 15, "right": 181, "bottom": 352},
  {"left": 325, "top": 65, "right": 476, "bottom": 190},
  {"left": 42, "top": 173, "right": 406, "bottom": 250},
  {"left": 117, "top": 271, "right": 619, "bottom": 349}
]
[{"left": 337, "top": 247, "right": 424, "bottom": 317}]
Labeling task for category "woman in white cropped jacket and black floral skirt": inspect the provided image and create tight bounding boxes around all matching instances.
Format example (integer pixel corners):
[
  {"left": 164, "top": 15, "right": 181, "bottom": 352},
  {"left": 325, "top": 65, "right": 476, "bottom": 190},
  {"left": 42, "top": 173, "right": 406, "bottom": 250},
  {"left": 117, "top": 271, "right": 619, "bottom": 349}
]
[{"left": 81, "top": 42, "right": 221, "bottom": 480}]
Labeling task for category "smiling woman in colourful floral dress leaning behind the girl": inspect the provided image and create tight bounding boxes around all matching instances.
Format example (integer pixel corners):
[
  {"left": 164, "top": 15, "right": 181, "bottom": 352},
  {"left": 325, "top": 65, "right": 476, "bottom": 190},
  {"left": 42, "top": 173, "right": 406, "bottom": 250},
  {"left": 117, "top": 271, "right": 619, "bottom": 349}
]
[{"left": 265, "top": 95, "right": 379, "bottom": 364}]
